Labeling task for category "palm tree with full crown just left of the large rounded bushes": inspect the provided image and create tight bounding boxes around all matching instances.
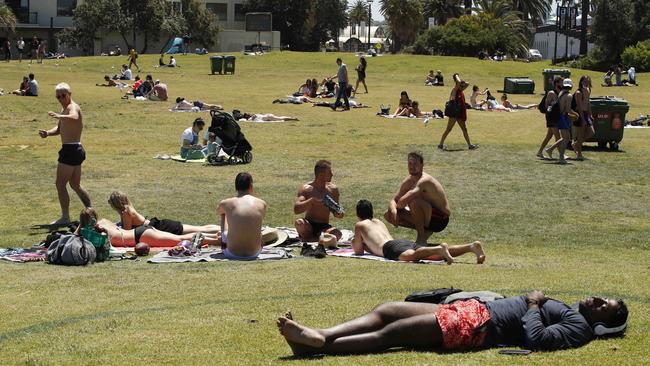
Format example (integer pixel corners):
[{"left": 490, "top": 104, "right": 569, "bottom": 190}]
[{"left": 381, "top": 0, "right": 424, "bottom": 51}]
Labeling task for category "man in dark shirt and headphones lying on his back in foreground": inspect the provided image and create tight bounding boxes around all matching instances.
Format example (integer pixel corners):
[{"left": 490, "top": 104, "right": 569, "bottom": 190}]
[{"left": 277, "top": 291, "right": 628, "bottom": 356}]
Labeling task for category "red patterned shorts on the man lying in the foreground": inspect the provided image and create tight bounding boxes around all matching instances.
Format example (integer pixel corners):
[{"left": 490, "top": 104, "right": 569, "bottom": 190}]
[{"left": 436, "top": 300, "right": 490, "bottom": 349}]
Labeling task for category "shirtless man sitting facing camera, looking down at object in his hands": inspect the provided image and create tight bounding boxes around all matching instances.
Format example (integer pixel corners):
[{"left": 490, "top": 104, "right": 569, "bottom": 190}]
[{"left": 293, "top": 160, "right": 344, "bottom": 246}]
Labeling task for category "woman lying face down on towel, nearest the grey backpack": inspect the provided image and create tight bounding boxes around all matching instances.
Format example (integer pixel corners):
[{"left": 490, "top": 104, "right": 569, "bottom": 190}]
[{"left": 79, "top": 207, "right": 221, "bottom": 247}]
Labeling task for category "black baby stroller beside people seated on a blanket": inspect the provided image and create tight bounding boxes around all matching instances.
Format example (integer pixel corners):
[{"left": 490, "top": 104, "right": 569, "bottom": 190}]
[{"left": 206, "top": 110, "right": 253, "bottom": 165}]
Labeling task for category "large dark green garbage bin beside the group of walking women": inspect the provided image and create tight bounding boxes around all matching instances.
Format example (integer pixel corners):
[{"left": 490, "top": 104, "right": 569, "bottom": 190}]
[{"left": 587, "top": 96, "right": 630, "bottom": 151}]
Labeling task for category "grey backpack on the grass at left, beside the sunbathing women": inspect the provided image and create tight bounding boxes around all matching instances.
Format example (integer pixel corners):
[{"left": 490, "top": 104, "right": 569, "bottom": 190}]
[{"left": 45, "top": 234, "right": 97, "bottom": 266}]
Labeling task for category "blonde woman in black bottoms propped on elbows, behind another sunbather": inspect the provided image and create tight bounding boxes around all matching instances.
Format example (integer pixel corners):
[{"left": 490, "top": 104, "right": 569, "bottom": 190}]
[{"left": 108, "top": 191, "right": 221, "bottom": 235}]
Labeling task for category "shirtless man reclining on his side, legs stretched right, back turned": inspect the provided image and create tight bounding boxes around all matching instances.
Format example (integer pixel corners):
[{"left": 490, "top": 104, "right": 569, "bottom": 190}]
[{"left": 352, "top": 200, "right": 485, "bottom": 264}]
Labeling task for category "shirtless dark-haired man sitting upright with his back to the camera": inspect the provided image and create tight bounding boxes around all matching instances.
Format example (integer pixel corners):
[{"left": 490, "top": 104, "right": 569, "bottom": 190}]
[{"left": 217, "top": 172, "right": 266, "bottom": 260}]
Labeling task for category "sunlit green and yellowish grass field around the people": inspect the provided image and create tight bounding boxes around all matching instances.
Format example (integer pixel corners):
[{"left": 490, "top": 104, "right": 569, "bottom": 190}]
[{"left": 0, "top": 52, "right": 650, "bottom": 365}]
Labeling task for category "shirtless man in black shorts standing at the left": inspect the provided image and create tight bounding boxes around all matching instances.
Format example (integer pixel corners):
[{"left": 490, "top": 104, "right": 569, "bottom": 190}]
[{"left": 38, "top": 83, "right": 92, "bottom": 225}]
